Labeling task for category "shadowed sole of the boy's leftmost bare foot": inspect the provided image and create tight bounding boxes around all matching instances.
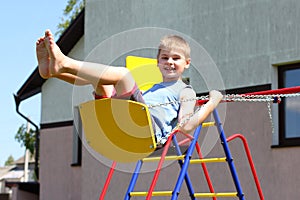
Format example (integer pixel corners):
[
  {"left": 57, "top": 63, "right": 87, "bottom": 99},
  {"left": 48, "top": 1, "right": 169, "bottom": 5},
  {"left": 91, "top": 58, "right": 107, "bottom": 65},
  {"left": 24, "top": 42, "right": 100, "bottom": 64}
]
[{"left": 36, "top": 37, "right": 50, "bottom": 79}]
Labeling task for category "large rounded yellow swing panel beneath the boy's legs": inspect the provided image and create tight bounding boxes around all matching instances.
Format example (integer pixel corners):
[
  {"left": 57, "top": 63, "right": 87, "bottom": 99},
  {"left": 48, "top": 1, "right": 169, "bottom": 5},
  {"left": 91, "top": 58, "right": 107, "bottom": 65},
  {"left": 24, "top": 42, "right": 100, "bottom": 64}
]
[{"left": 79, "top": 99, "right": 156, "bottom": 162}]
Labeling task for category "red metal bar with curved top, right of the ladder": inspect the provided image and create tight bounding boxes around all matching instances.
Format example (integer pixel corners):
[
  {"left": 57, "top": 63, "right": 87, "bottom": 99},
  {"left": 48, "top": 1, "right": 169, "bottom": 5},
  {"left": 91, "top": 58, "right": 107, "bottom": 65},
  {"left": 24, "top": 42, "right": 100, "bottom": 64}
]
[{"left": 227, "top": 134, "right": 264, "bottom": 200}]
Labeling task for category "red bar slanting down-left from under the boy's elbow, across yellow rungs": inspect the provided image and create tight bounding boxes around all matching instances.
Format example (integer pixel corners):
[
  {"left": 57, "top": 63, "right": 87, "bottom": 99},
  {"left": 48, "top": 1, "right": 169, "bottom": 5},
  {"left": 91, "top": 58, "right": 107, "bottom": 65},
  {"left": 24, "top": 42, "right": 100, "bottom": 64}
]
[{"left": 146, "top": 129, "right": 179, "bottom": 200}]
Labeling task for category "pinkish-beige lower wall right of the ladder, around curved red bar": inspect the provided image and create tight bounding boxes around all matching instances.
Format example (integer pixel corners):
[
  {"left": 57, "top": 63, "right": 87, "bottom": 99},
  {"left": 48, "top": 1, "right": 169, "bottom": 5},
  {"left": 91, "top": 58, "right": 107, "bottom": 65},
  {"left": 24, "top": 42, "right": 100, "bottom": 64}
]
[{"left": 213, "top": 103, "right": 300, "bottom": 200}]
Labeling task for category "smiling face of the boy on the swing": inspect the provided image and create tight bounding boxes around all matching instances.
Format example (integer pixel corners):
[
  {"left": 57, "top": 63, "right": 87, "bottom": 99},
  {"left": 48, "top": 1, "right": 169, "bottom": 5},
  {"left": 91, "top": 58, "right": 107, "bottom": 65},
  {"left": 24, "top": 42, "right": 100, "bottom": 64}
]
[{"left": 157, "top": 50, "right": 191, "bottom": 82}]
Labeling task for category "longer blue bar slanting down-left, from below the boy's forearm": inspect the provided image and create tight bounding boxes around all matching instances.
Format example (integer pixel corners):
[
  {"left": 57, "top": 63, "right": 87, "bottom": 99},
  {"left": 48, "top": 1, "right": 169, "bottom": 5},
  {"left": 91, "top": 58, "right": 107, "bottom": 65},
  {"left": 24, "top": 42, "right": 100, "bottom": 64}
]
[{"left": 171, "top": 125, "right": 202, "bottom": 200}]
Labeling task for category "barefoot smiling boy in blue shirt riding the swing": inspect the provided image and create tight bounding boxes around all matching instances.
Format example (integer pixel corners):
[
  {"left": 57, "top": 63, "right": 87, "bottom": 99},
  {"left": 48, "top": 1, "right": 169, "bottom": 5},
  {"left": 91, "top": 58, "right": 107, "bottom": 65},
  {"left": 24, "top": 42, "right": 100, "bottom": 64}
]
[{"left": 36, "top": 30, "right": 223, "bottom": 144}]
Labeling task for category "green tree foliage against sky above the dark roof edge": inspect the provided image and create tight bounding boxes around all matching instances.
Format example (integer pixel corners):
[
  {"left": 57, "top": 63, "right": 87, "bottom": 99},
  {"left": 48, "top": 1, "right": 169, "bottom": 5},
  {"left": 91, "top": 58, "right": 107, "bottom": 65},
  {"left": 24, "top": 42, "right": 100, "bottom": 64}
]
[{"left": 55, "top": 0, "right": 85, "bottom": 36}]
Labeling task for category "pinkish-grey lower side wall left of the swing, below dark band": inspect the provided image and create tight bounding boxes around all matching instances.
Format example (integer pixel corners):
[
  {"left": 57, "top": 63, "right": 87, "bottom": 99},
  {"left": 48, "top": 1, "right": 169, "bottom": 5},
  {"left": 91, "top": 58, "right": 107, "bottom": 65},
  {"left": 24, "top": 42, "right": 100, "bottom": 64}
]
[{"left": 40, "top": 127, "right": 82, "bottom": 200}]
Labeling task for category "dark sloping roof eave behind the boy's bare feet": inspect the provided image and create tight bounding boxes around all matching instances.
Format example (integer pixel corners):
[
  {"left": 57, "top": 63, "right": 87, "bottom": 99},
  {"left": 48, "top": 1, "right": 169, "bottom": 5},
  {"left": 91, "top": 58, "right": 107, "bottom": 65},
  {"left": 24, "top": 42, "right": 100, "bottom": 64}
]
[{"left": 15, "top": 9, "right": 84, "bottom": 105}]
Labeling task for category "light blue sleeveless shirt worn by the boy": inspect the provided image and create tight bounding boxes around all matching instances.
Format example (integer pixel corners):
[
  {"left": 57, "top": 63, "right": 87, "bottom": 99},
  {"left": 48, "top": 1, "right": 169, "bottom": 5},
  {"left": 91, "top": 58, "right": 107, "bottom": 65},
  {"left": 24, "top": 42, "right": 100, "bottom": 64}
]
[{"left": 143, "top": 80, "right": 191, "bottom": 144}]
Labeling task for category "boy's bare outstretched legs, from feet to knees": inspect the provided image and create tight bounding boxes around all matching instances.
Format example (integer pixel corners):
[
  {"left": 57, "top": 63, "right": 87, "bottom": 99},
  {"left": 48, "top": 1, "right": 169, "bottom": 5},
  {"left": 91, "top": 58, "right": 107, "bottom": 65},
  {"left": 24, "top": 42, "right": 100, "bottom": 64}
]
[{"left": 37, "top": 30, "right": 135, "bottom": 96}]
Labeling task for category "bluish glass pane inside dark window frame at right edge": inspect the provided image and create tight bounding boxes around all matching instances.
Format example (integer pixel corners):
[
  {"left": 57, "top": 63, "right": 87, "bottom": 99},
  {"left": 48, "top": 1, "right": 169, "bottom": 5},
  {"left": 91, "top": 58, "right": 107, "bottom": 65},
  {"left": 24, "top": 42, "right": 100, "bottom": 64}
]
[{"left": 284, "top": 69, "right": 300, "bottom": 138}]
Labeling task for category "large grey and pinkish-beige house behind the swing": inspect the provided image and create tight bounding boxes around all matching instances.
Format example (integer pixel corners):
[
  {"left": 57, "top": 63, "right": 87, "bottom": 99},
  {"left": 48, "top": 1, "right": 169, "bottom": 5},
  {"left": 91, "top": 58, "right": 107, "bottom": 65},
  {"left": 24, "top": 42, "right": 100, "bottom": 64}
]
[{"left": 15, "top": 0, "right": 300, "bottom": 200}]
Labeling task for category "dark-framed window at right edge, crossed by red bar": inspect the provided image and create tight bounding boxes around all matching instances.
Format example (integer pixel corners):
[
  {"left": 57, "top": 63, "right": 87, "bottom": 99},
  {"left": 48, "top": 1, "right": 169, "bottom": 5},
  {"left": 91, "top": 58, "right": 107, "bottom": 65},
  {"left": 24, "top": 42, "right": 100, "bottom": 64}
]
[{"left": 278, "top": 63, "right": 300, "bottom": 146}]
